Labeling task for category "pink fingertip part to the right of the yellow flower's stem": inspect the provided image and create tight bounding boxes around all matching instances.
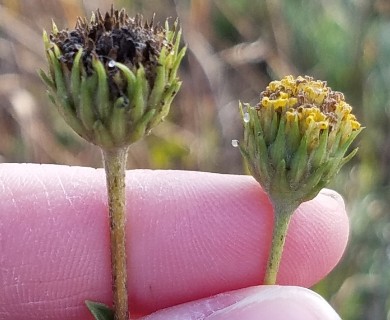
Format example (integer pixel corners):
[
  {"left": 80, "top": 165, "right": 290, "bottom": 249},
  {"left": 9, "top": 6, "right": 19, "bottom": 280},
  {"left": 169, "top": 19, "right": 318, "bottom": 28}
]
[{"left": 277, "top": 189, "right": 349, "bottom": 287}]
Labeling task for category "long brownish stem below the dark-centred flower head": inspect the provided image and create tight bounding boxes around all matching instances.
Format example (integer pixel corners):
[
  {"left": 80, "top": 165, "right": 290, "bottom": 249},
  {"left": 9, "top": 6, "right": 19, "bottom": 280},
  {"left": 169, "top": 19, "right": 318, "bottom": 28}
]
[{"left": 103, "top": 147, "right": 130, "bottom": 320}]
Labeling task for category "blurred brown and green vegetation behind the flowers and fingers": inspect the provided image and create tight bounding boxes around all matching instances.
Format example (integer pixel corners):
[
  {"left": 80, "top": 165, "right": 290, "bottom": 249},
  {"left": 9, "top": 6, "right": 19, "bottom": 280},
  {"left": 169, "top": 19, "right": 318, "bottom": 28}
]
[{"left": 0, "top": 0, "right": 390, "bottom": 320}]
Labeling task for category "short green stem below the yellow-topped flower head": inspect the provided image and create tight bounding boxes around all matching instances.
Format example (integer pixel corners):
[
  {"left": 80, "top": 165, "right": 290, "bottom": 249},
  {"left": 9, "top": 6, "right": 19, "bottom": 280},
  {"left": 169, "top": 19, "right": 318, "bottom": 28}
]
[{"left": 264, "top": 205, "right": 294, "bottom": 285}]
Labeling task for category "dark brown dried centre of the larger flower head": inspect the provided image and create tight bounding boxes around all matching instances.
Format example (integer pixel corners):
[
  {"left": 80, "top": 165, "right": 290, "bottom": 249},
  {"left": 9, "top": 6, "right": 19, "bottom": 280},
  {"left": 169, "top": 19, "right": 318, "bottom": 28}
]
[{"left": 50, "top": 8, "right": 171, "bottom": 87}]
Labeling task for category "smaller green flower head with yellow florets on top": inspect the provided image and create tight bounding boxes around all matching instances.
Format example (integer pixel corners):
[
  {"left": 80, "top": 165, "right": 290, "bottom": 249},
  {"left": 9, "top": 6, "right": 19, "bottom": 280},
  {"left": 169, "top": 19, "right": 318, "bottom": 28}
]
[{"left": 239, "top": 76, "right": 362, "bottom": 206}]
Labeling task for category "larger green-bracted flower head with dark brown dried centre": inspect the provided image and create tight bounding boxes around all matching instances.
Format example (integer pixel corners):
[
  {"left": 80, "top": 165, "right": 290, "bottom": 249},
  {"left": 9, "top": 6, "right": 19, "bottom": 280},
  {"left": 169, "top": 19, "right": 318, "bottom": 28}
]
[{"left": 41, "top": 8, "right": 185, "bottom": 149}]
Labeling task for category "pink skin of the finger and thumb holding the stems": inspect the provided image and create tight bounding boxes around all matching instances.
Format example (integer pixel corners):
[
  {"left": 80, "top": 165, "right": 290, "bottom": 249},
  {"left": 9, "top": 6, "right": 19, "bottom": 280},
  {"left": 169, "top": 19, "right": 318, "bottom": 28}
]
[{"left": 0, "top": 164, "right": 348, "bottom": 320}]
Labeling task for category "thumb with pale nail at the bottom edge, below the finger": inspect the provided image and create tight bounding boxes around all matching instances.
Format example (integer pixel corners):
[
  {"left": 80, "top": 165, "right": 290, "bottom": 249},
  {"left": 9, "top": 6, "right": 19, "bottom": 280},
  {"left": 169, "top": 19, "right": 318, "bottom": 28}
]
[{"left": 142, "top": 286, "right": 341, "bottom": 320}]
